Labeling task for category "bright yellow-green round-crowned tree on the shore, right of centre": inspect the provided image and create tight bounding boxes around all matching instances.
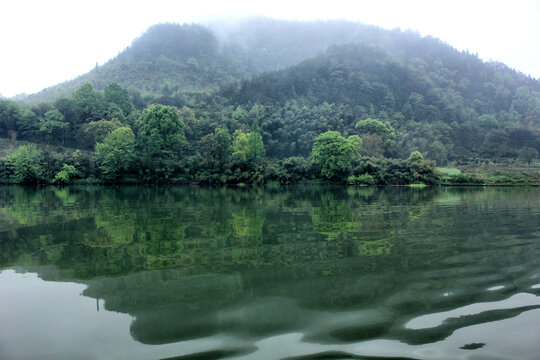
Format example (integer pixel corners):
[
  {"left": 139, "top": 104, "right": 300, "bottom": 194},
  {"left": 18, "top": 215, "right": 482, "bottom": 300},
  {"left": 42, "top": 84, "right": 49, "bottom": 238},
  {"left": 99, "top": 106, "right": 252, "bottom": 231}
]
[{"left": 312, "top": 131, "right": 359, "bottom": 179}]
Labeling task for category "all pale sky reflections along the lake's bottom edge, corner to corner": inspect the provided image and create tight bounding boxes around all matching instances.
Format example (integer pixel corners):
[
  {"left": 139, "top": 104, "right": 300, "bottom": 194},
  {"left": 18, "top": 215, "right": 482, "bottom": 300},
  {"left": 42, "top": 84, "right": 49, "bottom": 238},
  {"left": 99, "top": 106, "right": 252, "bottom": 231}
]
[{"left": 0, "top": 270, "right": 540, "bottom": 360}]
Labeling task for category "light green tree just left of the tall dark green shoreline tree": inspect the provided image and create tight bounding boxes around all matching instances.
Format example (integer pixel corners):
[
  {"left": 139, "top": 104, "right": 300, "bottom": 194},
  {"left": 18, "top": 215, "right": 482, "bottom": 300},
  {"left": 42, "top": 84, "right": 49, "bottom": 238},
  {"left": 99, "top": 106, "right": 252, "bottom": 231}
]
[{"left": 95, "top": 126, "right": 135, "bottom": 180}]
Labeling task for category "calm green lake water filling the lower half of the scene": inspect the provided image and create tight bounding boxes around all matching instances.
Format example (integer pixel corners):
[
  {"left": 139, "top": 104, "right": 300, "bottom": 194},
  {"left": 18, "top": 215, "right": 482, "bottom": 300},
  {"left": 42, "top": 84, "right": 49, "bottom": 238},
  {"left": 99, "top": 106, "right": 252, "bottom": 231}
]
[{"left": 0, "top": 187, "right": 540, "bottom": 360}]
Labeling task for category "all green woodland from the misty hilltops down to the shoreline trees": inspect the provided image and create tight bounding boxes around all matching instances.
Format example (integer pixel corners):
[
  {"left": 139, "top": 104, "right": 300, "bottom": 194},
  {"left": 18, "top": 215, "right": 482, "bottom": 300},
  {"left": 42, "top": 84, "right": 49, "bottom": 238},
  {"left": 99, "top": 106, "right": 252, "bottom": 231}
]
[{"left": 0, "top": 19, "right": 540, "bottom": 185}]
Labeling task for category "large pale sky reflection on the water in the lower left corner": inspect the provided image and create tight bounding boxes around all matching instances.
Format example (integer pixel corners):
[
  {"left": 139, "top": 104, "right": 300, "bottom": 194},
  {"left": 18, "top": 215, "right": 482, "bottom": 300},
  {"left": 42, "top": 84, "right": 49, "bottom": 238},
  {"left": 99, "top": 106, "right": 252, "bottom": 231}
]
[{"left": 0, "top": 270, "right": 232, "bottom": 360}]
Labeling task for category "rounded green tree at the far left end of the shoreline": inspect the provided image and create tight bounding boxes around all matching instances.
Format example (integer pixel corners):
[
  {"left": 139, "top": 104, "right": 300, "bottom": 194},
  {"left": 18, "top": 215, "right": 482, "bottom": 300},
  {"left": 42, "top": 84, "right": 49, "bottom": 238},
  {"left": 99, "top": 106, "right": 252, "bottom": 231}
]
[{"left": 6, "top": 145, "right": 43, "bottom": 183}]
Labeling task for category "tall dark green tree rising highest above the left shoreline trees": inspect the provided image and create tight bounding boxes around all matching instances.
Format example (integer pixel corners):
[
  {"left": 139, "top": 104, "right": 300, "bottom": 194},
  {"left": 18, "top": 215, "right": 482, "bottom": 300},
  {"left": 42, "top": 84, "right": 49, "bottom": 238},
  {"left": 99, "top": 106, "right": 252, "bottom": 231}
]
[{"left": 137, "top": 105, "right": 184, "bottom": 159}]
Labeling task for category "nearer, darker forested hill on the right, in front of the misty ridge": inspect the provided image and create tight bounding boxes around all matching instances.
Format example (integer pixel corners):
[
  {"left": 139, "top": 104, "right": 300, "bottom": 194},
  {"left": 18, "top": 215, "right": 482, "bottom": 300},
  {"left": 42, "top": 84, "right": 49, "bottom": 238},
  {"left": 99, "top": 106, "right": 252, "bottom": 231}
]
[{"left": 221, "top": 39, "right": 540, "bottom": 159}]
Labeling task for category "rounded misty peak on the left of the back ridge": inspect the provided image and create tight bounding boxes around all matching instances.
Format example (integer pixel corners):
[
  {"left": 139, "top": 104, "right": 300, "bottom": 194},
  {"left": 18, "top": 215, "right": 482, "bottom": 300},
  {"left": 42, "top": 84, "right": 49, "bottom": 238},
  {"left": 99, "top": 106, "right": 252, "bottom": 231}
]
[{"left": 26, "top": 24, "right": 244, "bottom": 102}]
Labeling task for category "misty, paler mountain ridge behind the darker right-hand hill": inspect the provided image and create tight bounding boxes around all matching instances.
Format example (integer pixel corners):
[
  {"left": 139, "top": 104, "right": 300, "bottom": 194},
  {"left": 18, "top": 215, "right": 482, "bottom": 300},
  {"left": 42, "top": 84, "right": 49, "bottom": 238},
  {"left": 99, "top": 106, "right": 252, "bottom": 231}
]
[{"left": 25, "top": 18, "right": 396, "bottom": 102}]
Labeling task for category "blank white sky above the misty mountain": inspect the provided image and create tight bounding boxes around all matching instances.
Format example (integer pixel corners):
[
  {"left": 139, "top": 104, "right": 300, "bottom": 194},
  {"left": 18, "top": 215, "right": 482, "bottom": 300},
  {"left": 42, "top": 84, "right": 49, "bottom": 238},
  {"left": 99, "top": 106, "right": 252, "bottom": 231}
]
[{"left": 0, "top": 0, "right": 540, "bottom": 96}]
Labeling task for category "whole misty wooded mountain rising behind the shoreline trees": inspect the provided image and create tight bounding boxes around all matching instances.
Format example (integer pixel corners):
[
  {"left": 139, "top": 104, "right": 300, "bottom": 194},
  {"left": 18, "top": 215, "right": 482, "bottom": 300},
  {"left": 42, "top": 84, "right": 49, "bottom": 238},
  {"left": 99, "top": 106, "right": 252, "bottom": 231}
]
[{"left": 0, "top": 18, "right": 540, "bottom": 181}]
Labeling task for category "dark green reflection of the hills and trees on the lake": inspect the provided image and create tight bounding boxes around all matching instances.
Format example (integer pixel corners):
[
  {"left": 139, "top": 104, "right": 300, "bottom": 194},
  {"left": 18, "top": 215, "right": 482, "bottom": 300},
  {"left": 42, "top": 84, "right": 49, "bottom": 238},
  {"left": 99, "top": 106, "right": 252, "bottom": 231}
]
[{"left": 0, "top": 187, "right": 540, "bottom": 358}]
